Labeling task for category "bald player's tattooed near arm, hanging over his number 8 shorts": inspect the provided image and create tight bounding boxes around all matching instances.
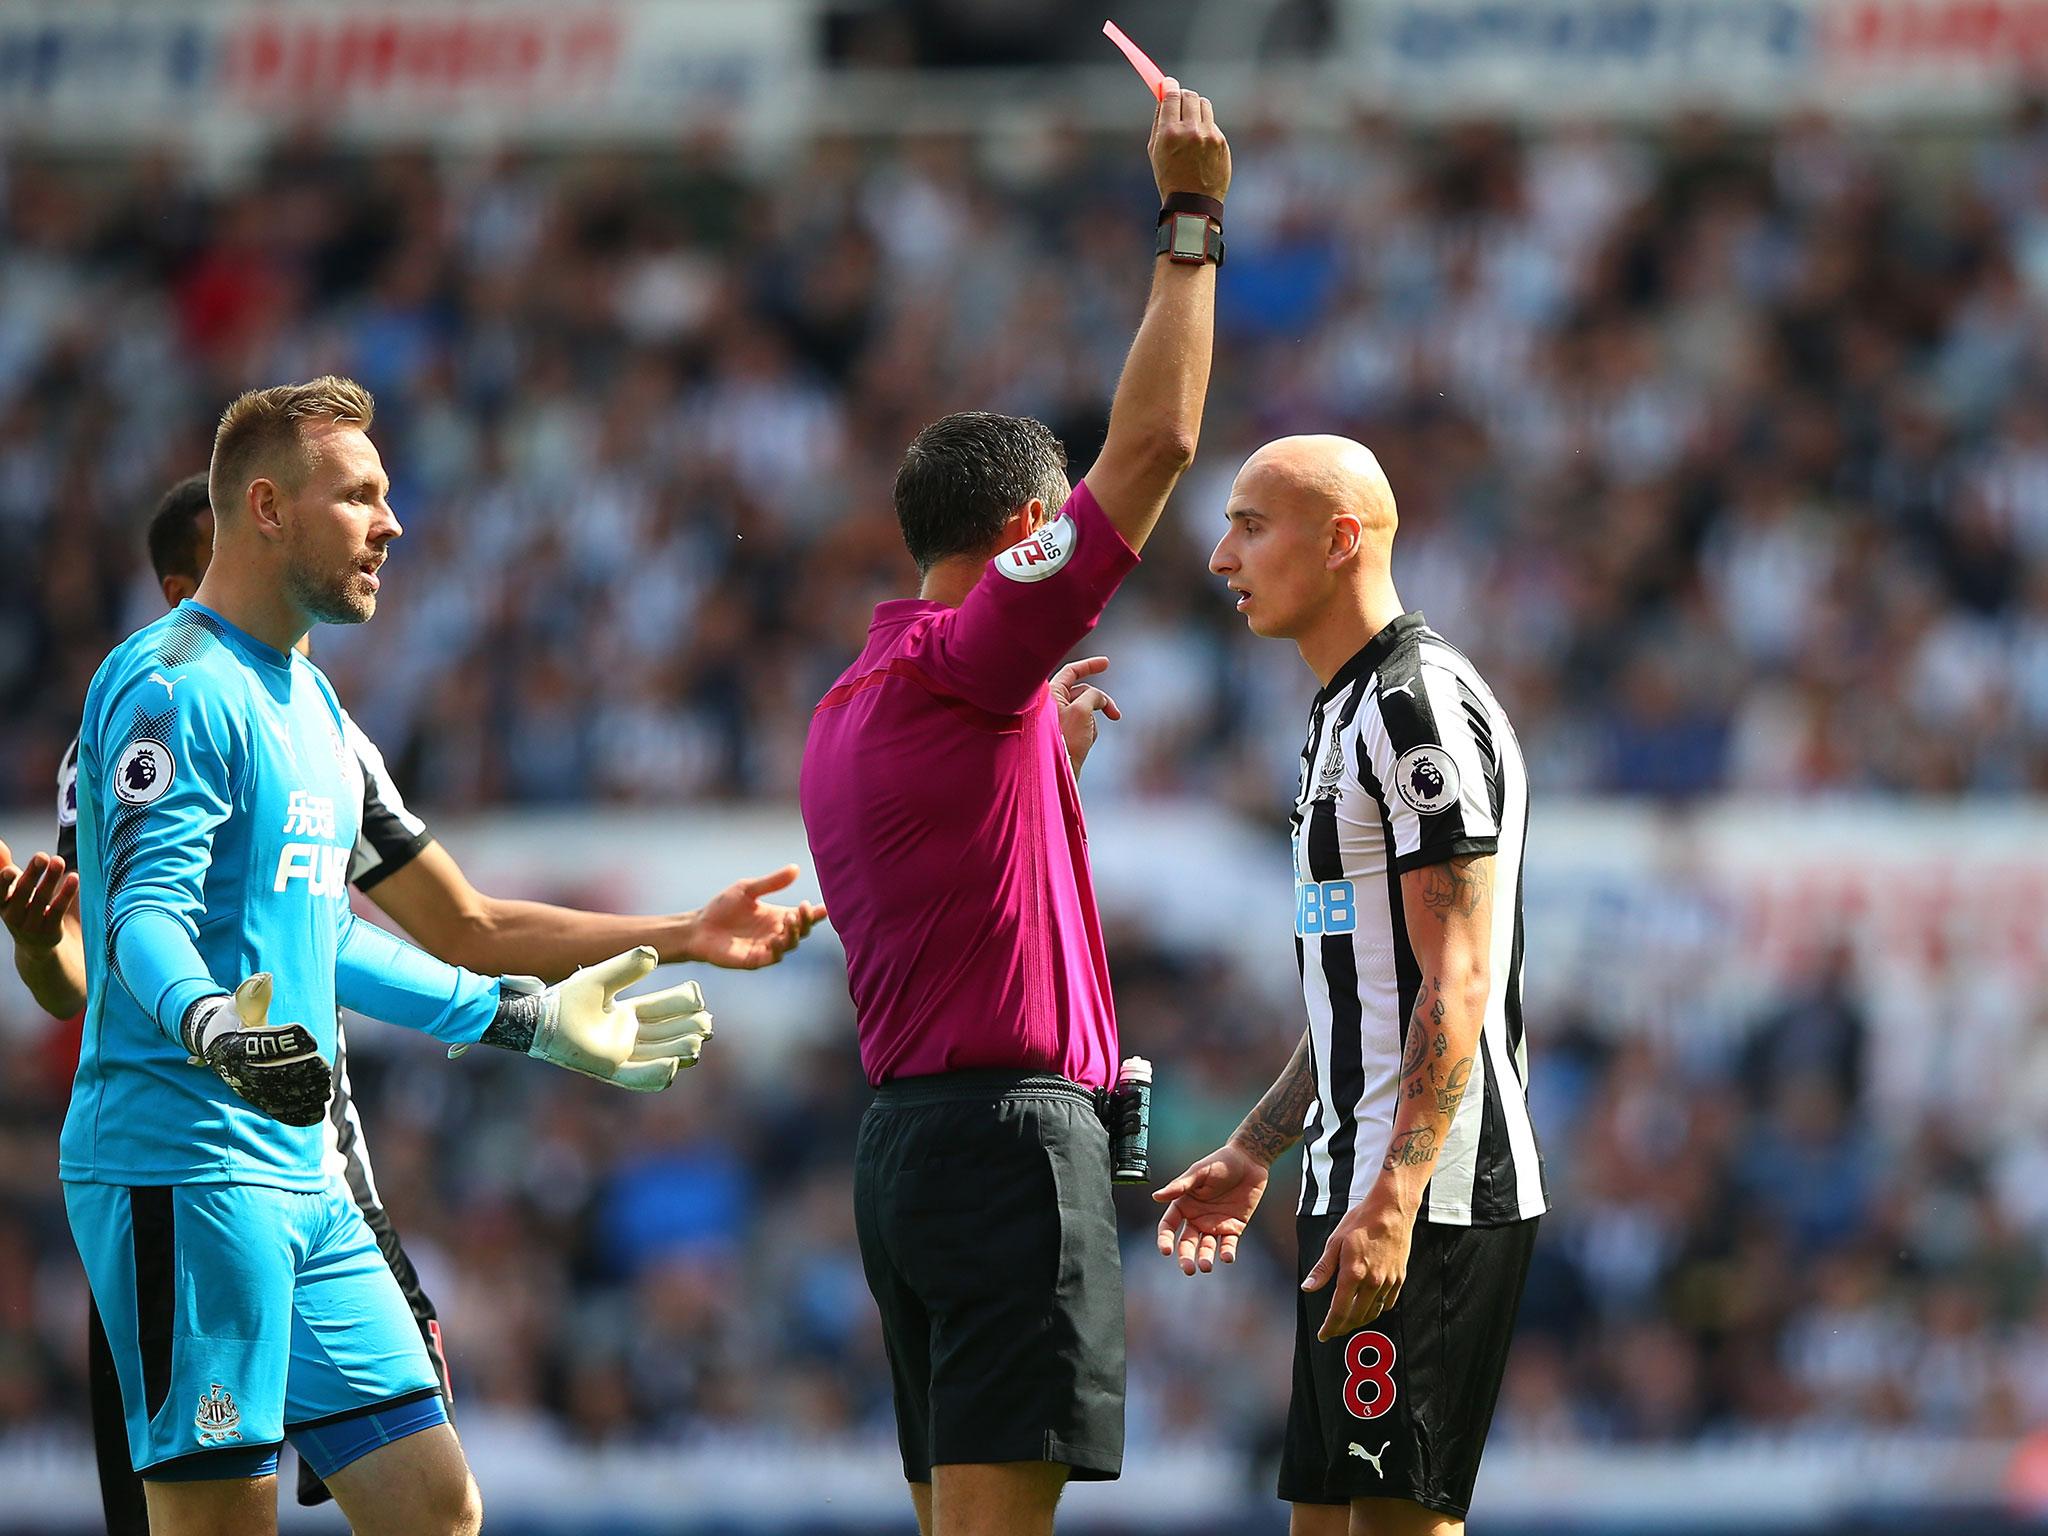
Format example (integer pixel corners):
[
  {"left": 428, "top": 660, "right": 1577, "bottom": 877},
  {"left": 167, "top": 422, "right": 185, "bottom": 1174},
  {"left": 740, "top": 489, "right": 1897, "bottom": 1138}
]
[{"left": 1303, "top": 854, "right": 1493, "bottom": 1339}]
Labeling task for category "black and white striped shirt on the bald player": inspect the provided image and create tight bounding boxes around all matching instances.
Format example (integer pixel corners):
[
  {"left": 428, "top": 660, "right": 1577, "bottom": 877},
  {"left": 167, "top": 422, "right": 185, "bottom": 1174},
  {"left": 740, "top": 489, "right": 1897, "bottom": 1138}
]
[{"left": 1292, "top": 612, "right": 1546, "bottom": 1227}]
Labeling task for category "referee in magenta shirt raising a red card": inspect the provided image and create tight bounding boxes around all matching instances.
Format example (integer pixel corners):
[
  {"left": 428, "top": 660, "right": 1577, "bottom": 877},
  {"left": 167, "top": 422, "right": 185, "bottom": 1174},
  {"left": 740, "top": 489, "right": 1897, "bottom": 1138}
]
[{"left": 801, "top": 80, "right": 1231, "bottom": 1536}]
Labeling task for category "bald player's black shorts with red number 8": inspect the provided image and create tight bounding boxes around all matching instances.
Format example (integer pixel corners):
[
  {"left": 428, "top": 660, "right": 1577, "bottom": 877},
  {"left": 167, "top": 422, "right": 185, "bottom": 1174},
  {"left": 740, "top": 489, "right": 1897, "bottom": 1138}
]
[{"left": 1280, "top": 1217, "right": 1536, "bottom": 1520}]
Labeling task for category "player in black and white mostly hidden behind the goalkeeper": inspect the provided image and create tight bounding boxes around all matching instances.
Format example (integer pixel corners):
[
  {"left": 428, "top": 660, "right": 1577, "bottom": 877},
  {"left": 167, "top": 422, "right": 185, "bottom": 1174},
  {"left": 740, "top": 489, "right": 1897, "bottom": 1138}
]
[{"left": 0, "top": 475, "right": 823, "bottom": 1536}]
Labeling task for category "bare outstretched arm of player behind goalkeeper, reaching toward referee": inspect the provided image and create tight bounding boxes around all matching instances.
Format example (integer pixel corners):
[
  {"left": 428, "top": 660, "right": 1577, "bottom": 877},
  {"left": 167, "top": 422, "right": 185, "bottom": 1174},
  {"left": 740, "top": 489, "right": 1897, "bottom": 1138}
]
[{"left": 365, "top": 842, "right": 825, "bottom": 981}]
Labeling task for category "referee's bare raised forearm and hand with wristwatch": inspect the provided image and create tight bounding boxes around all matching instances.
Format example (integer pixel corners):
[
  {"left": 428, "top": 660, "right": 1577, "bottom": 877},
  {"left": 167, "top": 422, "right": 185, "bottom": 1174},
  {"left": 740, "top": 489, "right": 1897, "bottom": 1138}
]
[{"left": 1083, "top": 80, "right": 1231, "bottom": 549}]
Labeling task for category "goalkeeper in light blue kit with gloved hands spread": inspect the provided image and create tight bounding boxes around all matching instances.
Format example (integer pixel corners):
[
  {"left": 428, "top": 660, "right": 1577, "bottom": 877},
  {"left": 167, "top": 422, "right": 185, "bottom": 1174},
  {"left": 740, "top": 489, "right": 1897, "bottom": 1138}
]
[{"left": 59, "top": 379, "right": 711, "bottom": 1536}]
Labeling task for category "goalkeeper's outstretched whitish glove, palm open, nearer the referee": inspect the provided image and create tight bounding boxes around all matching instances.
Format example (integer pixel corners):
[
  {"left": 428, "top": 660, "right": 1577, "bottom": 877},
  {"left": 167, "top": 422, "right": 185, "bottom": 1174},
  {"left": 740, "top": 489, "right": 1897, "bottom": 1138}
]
[{"left": 466, "top": 944, "right": 711, "bottom": 1094}]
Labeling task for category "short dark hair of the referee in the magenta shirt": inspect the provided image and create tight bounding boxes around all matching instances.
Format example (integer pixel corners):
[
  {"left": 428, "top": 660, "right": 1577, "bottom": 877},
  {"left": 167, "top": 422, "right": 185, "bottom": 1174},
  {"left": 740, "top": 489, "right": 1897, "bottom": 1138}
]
[{"left": 895, "top": 412, "right": 1067, "bottom": 575}]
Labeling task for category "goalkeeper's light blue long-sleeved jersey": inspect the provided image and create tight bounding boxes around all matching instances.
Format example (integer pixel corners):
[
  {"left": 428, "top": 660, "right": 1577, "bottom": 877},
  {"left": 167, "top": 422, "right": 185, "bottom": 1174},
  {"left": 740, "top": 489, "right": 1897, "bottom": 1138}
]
[{"left": 59, "top": 602, "right": 498, "bottom": 1190}]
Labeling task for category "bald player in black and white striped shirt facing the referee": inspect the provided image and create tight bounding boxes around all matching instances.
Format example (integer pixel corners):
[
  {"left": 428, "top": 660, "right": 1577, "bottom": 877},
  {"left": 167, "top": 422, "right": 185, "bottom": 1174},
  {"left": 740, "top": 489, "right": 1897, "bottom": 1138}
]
[{"left": 1153, "top": 436, "right": 1544, "bottom": 1536}]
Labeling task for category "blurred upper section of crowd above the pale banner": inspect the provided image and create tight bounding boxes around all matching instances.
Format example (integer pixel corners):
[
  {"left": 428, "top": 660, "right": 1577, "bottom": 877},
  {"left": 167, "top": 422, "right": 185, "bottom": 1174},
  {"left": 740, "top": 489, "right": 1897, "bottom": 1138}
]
[{"left": 0, "top": 111, "right": 2048, "bottom": 809}]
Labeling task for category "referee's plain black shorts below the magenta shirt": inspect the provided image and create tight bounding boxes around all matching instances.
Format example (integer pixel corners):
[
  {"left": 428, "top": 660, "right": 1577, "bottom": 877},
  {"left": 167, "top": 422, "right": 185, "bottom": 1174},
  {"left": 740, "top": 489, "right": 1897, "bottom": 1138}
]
[{"left": 854, "top": 1071, "right": 1124, "bottom": 1483}]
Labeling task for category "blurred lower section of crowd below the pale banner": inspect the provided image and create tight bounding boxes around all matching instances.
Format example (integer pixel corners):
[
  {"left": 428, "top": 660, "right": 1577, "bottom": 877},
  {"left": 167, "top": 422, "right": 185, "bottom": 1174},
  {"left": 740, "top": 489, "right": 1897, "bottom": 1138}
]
[{"left": 0, "top": 930, "right": 2048, "bottom": 1485}]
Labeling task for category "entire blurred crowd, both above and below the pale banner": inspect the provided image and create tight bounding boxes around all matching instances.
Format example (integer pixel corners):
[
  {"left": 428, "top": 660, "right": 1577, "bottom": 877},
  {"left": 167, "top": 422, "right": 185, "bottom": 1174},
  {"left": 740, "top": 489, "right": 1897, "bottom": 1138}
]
[{"left": 0, "top": 111, "right": 2048, "bottom": 1474}]
